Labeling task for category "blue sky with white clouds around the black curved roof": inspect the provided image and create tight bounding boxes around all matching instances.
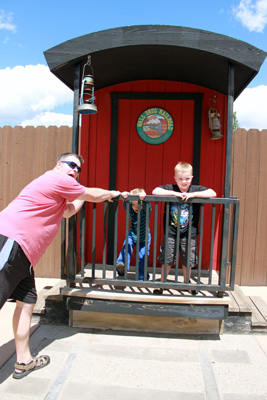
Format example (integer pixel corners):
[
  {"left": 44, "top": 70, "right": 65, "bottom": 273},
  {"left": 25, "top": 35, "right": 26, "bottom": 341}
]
[{"left": 0, "top": 0, "right": 267, "bottom": 129}]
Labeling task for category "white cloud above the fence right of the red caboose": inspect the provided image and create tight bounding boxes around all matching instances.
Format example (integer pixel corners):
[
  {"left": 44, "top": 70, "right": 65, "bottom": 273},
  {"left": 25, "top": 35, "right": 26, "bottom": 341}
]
[{"left": 234, "top": 85, "right": 267, "bottom": 130}]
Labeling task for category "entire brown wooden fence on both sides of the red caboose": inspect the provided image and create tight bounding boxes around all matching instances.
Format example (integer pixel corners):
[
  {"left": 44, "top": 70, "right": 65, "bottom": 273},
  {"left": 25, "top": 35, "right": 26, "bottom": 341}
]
[{"left": 0, "top": 126, "right": 267, "bottom": 286}]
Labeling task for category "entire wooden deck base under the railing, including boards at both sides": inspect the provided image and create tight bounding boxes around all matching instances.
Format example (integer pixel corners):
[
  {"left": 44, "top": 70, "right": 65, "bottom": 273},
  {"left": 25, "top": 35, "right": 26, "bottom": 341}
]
[{"left": 34, "top": 280, "right": 267, "bottom": 334}]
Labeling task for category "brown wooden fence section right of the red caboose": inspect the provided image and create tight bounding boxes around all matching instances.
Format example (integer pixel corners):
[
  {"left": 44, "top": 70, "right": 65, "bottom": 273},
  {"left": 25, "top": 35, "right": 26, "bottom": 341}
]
[{"left": 231, "top": 129, "right": 267, "bottom": 286}]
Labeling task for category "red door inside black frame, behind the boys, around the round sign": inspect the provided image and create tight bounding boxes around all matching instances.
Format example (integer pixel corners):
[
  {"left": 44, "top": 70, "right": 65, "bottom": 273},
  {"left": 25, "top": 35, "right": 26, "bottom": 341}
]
[{"left": 116, "top": 99, "right": 194, "bottom": 264}]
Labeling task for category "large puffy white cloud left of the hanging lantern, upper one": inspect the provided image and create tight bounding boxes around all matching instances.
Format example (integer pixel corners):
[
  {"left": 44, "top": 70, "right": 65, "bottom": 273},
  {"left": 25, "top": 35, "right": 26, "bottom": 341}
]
[{"left": 0, "top": 64, "right": 73, "bottom": 125}]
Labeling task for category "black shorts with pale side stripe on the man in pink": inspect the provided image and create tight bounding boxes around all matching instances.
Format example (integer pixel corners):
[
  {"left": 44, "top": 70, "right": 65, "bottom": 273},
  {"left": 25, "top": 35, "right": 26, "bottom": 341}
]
[{"left": 0, "top": 235, "right": 37, "bottom": 309}]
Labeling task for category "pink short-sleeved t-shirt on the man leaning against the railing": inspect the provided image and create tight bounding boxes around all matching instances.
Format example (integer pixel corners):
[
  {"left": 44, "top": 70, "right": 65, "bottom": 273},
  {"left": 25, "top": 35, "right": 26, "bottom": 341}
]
[{"left": 0, "top": 171, "right": 85, "bottom": 265}]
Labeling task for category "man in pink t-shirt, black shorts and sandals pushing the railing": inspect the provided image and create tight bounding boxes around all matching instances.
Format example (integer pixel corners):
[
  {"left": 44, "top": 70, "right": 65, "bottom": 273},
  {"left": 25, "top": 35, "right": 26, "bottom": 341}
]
[{"left": 0, "top": 153, "right": 121, "bottom": 379}]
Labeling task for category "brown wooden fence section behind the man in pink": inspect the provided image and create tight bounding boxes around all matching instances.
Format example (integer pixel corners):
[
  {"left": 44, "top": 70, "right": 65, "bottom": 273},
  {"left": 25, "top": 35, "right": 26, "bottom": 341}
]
[{"left": 0, "top": 126, "right": 72, "bottom": 278}]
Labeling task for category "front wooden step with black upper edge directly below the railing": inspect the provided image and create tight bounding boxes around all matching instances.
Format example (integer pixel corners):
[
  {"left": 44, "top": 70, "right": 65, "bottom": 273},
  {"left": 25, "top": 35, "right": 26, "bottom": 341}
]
[{"left": 61, "top": 283, "right": 230, "bottom": 334}]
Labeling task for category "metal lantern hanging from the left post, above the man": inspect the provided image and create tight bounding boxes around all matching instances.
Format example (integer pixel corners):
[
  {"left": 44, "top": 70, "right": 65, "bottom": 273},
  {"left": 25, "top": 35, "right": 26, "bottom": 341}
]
[{"left": 77, "top": 55, "right": 97, "bottom": 114}]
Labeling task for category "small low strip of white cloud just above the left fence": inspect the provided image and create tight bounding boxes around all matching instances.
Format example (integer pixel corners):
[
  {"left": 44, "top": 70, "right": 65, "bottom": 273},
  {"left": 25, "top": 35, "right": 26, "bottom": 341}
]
[{"left": 21, "top": 112, "right": 73, "bottom": 128}]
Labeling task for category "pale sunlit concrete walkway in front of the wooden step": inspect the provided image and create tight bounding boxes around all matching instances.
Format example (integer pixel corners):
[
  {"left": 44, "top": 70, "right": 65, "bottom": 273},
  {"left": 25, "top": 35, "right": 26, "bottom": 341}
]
[{"left": 0, "top": 280, "right": 267, "bottom": 400}]
